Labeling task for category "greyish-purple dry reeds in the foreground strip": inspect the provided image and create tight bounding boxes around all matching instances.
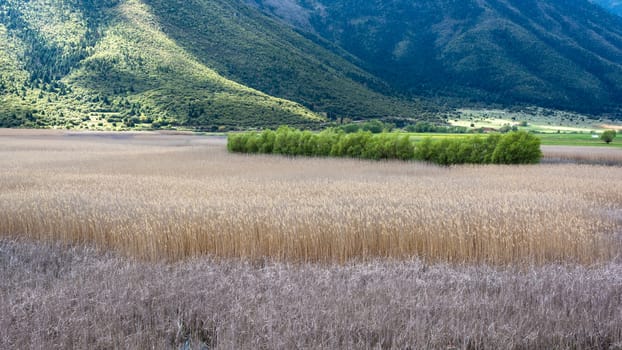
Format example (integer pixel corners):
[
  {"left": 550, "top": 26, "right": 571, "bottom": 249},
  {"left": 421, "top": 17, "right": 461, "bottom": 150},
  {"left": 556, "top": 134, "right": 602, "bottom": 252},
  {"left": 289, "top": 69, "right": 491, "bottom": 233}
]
[{"left": 0, "top": 239, "right": 622, "bottom": 350}]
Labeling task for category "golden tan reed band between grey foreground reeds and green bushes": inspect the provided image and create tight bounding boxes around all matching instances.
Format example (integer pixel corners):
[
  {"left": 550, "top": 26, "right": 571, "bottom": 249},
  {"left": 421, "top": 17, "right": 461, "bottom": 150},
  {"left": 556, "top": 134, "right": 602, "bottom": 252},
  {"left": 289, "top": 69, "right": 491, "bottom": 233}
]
[{"left": 0, "top": 134, "right": 622, "bottom": 264}]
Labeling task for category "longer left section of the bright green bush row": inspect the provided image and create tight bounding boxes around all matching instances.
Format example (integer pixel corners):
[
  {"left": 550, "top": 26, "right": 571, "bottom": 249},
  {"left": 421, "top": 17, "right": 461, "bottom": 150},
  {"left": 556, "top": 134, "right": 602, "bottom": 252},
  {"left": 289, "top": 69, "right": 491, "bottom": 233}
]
[{"left": 227, "top": 126, "right": 414, "bottom": 160}]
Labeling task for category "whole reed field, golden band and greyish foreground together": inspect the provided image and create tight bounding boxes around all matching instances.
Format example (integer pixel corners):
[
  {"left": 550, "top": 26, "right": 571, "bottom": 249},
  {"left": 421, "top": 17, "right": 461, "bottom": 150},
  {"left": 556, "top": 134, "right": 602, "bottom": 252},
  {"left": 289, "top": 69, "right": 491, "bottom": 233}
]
[{"left": 0, "top": 130, "right": 622, "bottom": 350}]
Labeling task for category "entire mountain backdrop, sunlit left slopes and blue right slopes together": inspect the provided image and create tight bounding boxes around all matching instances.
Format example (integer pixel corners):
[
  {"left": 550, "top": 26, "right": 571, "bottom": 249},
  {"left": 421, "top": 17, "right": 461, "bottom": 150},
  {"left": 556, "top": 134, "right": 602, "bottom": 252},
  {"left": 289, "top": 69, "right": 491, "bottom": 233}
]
[{"left": 0, "top": 0, "right": 622, "bottom": 130}]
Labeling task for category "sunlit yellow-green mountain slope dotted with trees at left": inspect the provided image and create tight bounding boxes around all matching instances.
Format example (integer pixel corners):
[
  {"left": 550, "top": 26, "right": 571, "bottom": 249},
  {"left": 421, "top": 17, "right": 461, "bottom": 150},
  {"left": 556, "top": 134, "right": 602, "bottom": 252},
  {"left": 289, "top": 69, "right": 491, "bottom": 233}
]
[{"left": 0, "top": 0, "right": 321, "bottom": 128}]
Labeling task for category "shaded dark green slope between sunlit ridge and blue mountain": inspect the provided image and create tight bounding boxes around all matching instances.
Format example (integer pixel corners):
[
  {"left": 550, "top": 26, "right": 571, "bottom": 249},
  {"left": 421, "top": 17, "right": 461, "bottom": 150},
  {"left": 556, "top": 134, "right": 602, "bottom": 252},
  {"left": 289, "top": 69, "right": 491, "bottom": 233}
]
[{"left": 139, "top": 0, "right": 426, "bottom": 119}]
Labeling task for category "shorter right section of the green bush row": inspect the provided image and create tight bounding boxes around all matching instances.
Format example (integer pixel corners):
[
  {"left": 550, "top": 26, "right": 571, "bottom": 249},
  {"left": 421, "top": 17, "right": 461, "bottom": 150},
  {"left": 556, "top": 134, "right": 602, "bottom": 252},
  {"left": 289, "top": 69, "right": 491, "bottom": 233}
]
[{"left": 415, "top": 131, "right": 542, "bottom": 165}]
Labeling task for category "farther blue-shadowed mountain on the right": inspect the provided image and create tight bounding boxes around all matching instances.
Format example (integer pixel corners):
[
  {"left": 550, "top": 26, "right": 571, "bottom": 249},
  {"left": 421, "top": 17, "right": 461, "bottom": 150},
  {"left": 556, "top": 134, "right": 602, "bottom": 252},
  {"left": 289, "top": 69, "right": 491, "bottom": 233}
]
[{"left": 251, "top": 0, "right": 622, "bottom": 113}]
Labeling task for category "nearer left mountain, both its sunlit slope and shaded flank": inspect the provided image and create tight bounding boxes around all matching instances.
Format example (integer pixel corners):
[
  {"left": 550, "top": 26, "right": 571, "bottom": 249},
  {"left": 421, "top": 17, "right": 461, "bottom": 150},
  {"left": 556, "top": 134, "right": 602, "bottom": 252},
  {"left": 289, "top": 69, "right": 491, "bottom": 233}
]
[{"left": 0, "top": 0, "right": 419, "bottom": 130}]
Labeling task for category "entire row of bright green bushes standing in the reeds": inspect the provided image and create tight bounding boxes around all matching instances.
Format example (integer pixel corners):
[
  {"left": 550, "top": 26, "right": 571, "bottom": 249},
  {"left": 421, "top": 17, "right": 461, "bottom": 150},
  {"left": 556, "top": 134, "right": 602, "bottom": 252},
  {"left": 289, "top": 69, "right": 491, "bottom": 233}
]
[{"left": 227, "top": 126, "right": 542, "bottom": 165}]
